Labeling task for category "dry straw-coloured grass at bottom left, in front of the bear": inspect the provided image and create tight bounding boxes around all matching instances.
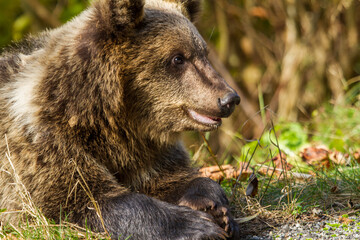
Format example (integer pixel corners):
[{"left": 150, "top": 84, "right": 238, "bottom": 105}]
[{"left": 0, "top": 136, "right": 110, "bottom": 239}]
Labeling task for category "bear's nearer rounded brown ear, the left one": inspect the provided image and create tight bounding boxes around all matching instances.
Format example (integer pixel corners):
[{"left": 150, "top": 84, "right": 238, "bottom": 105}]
[{"left": 99, "top": 0, "right": 145, "bottom": 33}]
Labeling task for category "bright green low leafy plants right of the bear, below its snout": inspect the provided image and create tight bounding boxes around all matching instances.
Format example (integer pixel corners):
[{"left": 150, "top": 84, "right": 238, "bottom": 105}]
[{"left": 236, "top": 101, "right": 360, "bottom": 171}]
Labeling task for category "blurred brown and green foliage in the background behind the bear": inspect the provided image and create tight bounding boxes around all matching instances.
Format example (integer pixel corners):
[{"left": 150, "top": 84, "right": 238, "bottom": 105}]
[{"left": 0, "top": 0, "right": 360, "bottom": 165}]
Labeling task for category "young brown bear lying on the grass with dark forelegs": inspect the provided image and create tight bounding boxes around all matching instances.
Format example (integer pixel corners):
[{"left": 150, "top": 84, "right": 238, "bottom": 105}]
[{"left": 0, "top": 0, "right": 240, "bottom": 240}]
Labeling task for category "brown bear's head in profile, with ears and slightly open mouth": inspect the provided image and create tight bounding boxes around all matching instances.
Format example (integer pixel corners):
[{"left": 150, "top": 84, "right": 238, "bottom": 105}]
[{"left": 56, "top": 0, "right": 240, "bottom": 142}]
